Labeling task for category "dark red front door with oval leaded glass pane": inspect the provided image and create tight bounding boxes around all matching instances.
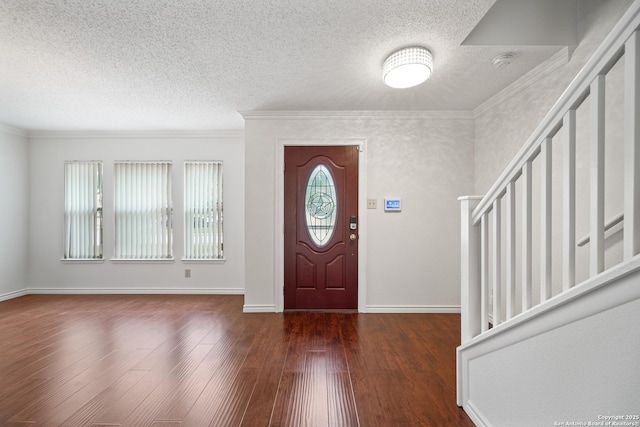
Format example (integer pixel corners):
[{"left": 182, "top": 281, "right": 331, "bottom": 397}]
[{"left": 284, "top": 146, "right": 359, "bottom": 310}]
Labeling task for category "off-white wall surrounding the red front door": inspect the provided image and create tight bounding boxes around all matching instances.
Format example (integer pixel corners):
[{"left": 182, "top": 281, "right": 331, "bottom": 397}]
[{"left": 245, "top": 112, "right": 473, "bottom": 311}]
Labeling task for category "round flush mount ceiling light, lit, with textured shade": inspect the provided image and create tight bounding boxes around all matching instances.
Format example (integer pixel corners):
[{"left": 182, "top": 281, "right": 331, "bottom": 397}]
[{"left": 382, "top": 46, "right": 433, "bottom": 89}]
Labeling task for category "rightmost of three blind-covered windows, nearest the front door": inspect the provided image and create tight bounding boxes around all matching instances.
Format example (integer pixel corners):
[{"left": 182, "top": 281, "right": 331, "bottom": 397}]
[{"left": 184, "top": 161, "right": 223, "bottom": 260}]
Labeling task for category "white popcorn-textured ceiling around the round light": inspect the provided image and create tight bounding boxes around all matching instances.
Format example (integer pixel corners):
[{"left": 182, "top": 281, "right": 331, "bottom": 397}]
[{"left": 0, "top": 0, "right": 560, "bottom": 130}]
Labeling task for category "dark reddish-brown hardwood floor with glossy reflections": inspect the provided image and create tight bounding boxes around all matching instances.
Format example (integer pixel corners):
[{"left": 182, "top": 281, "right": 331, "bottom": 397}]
[{"left": 0, "top": 295, "right": 473, "bottom": 427}]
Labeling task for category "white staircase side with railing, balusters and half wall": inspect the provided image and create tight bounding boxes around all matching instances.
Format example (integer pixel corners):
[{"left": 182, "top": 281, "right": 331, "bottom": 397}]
[{"left": 457, "top": 0, "right": 640, "bottom": 426}]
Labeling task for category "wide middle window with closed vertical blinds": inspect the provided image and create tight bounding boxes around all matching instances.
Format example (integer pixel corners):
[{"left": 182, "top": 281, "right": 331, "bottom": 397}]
[{"left": 113, "top": 162, "right": 173, "bottom": 260}]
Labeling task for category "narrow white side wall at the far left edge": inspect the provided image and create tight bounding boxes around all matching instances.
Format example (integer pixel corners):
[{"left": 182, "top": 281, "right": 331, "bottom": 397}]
[{"left": 0, "top": 125, "right": 29, "bottom": 301}]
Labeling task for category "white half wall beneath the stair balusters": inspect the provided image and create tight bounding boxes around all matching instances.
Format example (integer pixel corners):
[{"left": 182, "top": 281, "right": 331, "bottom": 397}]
[{"left": 458, "top": 256, "right": 640, "bottom": 427}]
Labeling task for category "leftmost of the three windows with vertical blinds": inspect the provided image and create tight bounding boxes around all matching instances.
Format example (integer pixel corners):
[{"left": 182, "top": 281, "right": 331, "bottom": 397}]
[{"left": 64, "top": 161, "right": 102, "bottom": 259}]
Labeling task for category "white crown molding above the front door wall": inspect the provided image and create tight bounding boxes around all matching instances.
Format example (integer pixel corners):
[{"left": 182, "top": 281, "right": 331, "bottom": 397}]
[{"left": 238, "top": 110, "right": 474, "bottom": 121}]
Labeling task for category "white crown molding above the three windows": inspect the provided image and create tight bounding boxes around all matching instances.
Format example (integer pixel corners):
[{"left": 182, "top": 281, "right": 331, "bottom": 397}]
[{"left": 26, "top": 130, "right": 244, "bottom": 139}]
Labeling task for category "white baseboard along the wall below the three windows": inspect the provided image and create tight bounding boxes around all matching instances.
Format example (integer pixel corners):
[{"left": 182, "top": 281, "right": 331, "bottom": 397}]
[{"left": 27, "top": 287, "right": 244, "bottom": 295}]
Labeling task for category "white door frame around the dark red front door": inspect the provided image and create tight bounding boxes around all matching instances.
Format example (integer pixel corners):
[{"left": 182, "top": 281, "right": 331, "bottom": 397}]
[{"left": 273, "top": 138, "right": 367, "bottom": 312}]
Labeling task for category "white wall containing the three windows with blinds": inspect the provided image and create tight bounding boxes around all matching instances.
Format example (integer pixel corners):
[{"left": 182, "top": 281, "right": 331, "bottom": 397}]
[{"left": 28, "top": 132, "right": 244, "bottom": 293}]
